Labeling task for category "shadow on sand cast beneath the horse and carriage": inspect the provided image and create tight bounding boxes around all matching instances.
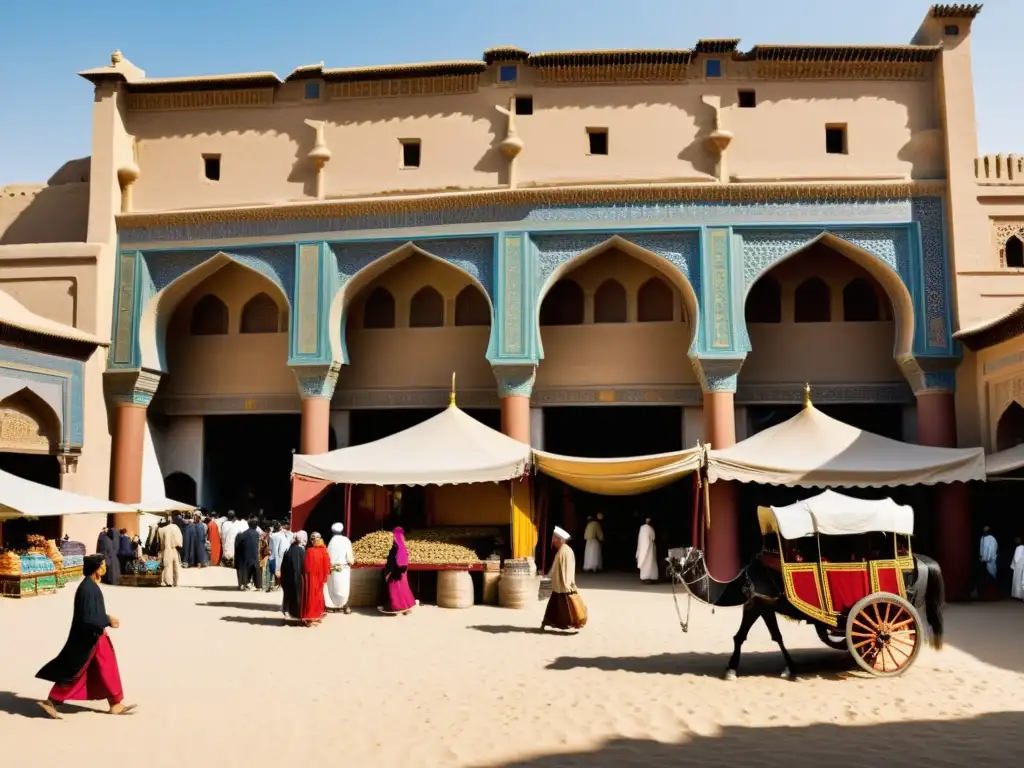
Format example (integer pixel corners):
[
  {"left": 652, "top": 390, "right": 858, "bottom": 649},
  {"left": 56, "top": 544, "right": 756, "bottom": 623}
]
[{"left": 546, "top": 649, "right": 867, "bottom": 680}]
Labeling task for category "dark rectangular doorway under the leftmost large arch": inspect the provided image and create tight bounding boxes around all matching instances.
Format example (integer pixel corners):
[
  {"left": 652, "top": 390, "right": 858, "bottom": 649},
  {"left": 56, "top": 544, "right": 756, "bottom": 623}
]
[{"left": 203, "top": 414, "right": 301, "bottom": 520}]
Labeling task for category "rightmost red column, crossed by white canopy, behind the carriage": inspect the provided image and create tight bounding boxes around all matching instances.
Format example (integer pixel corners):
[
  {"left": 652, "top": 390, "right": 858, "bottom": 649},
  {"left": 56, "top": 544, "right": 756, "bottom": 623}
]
[{"left": 918, "top": 390, "right": 974, "bottom": 600}]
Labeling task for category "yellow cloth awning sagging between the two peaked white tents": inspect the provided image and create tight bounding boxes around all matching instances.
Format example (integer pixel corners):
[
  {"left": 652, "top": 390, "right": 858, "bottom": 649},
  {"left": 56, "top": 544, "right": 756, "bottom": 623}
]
[{"left": 534, "top": 447, "right": 703, "bottom": 496}]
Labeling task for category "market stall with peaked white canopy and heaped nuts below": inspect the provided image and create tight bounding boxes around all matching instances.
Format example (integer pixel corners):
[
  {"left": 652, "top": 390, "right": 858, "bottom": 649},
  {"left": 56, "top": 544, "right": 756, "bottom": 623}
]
[{"left": 292, "top": 398, "right": 537, "bottom": 607}]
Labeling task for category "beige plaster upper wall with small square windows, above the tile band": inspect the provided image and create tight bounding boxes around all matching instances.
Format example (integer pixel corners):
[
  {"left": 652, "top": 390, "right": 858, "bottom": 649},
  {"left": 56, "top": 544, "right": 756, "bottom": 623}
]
[{"left": 127, "top": 78, "right": 943, "bottom": 211}]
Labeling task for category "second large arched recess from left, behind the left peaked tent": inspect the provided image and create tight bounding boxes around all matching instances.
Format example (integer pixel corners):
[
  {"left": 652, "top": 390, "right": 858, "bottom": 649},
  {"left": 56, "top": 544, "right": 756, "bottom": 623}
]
[{"left": 319, "top": 246, "right": 495, "bottom": 538}]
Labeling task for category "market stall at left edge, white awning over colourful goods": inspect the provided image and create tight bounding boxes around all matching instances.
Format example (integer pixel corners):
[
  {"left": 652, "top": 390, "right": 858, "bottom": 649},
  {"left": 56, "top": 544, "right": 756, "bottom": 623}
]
[{"left": 0, "top": 471, "right": 136, "bottom": 597}]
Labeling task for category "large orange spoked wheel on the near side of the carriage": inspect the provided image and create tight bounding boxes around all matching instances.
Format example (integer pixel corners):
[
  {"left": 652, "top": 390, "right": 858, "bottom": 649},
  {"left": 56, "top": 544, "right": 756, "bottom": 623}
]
[{"left": 846, "top": 592, "right": 922, "bottom": 677}]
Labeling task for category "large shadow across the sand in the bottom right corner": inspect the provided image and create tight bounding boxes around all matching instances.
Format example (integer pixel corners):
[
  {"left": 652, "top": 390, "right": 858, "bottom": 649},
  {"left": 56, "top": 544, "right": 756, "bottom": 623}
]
[{"left": 466, "top": 702, "right": 1024, "bottom": 768}]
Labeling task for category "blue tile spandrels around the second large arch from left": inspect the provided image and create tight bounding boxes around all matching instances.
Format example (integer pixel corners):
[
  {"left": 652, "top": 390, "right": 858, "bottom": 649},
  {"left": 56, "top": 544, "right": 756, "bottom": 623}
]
[{"left": 331, "top": 237, "right": 495, "bottom": 300}]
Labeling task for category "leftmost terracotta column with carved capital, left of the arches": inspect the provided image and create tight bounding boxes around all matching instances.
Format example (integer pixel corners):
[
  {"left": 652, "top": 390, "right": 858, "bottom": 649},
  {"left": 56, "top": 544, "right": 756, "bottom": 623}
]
[{"left": 103, "top": 369, "right": 161, "bottom": 536}]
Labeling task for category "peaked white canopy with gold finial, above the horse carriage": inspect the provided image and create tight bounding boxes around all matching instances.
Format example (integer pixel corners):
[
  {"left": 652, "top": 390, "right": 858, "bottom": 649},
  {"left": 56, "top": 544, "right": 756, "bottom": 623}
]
[{"left": 708, "top": 400, "right": 985, "bottom": 487}]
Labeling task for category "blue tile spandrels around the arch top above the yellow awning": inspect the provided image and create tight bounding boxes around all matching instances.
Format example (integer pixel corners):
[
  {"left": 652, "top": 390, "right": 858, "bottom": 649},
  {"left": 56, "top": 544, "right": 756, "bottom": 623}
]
[{"left": 532, "top": 229, "right": 700, "bottom": 296}]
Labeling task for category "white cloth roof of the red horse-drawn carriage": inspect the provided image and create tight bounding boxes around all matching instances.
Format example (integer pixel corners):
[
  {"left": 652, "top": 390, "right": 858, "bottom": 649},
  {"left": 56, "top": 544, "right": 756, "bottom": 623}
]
[{"left": 758, "top": 490, "right": 913, "bottom": 539}]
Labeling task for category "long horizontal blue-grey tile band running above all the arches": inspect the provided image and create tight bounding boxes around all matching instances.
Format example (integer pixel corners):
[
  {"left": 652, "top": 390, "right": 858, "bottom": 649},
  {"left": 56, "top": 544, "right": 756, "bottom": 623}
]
[{"left": 120, "top": 195, "right": 917, "bottom": 244}]
